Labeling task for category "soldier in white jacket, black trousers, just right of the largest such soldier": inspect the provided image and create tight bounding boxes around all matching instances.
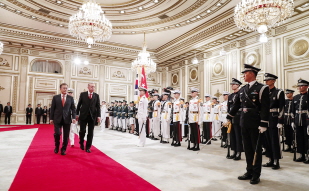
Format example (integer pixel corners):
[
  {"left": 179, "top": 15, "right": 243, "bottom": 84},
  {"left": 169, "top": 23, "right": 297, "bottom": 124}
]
[{"left": 201, "top": 94, "right": 212, "bottom": 144}]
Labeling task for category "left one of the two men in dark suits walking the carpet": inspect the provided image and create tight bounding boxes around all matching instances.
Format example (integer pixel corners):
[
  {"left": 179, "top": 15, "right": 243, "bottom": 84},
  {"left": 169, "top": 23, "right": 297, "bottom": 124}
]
[{"left": 50, "top": 83, "right": 76, "bottom": 155}]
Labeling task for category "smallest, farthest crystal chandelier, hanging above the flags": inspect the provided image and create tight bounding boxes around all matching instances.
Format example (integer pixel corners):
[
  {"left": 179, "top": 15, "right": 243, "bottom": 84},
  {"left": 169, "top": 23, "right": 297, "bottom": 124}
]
[{"left": 131, "top": 33, "right": 157, "bottom": 74}]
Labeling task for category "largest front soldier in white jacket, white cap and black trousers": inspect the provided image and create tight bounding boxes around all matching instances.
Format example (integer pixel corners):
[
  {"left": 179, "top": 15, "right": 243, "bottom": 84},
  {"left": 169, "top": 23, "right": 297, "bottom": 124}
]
[{"left": 188, "top": 88, "right": 202, "bottom": 151}]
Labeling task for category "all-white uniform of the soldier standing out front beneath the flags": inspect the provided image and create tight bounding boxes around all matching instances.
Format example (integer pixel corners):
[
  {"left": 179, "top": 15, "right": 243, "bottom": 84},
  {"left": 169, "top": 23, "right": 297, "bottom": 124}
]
[{"left": 137, "top": 96, "right": 148, "bottom": 147}]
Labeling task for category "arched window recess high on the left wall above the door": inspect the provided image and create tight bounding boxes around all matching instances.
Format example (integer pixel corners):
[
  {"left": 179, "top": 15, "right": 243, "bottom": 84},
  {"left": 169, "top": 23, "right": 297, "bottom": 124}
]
[{"left": 31, "top": 60, "right": 62, "bottom": 74}]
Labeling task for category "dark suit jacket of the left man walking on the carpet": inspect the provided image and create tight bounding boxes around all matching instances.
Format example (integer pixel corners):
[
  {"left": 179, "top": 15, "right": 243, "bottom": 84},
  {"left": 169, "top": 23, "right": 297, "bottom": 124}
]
[{"left": 50, "top": 94, "right": 76, "bottom": 124}]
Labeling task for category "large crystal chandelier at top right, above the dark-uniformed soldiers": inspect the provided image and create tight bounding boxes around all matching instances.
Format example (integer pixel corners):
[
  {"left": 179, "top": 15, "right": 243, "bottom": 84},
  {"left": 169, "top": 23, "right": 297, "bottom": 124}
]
[{"left": 234, "top": 0, "right": 294, "bottom": 42}]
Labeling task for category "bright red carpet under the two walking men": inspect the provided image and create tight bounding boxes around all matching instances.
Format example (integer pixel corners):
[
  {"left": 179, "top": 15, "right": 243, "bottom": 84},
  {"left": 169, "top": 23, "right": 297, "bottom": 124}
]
[{"left": 10, "top": 125, "right": 159, "bottom": 191}]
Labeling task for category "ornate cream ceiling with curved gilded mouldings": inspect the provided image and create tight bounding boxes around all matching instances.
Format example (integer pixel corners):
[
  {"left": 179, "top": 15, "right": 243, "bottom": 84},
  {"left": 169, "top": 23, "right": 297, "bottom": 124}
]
[{"left": 0, "top": 0, "right": 306, "bottom": 64}]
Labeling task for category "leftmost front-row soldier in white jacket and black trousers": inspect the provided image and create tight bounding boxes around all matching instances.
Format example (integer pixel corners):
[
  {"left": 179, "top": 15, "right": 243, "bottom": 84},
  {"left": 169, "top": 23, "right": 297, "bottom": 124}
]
[{"left": 171, "top": 90, "right": 183, "bottom": 147}]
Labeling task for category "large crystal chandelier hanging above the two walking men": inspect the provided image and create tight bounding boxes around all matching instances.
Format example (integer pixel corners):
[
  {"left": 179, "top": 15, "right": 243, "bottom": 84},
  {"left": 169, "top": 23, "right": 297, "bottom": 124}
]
[{"left": 69, "top": 0, "right": 112, "bottom": 48}]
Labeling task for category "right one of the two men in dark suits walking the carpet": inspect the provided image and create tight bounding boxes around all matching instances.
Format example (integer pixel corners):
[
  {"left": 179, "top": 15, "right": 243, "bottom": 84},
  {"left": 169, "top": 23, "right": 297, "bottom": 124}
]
[{"left": 76, "top": 83, "right": 101, "bottom": 153}]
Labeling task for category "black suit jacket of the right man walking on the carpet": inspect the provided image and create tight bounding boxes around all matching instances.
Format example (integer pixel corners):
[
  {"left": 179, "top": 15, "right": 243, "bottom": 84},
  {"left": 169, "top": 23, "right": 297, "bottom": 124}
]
[{"left": 76, "top": 91, "right": 101, "bottom": 120}]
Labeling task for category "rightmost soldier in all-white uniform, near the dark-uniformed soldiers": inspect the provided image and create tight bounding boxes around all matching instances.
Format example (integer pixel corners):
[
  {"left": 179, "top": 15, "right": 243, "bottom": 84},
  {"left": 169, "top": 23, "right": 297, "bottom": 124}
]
[{"left": 211, "top": 96, "right": 222, "bottom": 142}]
